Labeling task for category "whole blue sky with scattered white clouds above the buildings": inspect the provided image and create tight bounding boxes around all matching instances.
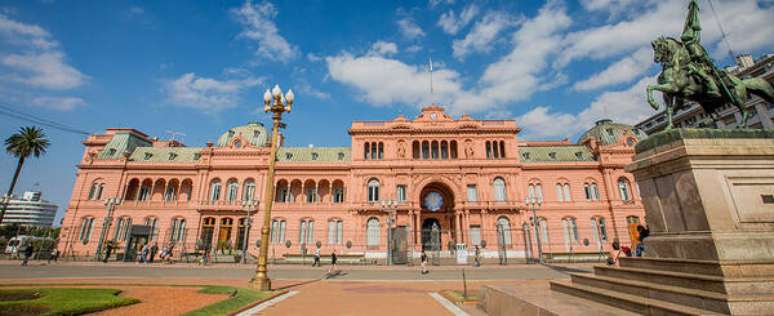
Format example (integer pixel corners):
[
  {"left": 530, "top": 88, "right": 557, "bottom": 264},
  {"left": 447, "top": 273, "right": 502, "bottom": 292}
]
[{"left": 0, "top": 0, "right": 774, "bottom": 225}]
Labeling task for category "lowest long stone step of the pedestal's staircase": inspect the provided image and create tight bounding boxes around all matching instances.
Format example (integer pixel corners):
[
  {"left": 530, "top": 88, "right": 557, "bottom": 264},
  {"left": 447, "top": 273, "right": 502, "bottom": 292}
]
[{"left": 551, "top": 280, "right": 723, "bottom": 315}]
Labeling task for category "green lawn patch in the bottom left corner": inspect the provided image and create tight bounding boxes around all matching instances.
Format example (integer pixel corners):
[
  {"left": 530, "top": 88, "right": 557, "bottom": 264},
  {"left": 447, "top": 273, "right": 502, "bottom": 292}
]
[{"left": 0, "top": 288, "right": 139, "bottom": 316}]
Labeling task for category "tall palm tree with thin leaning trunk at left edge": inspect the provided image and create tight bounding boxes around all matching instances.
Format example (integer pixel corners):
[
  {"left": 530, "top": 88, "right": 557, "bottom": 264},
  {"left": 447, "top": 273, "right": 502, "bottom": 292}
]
[{"left": 0, "top": 126, "right": 50, "bottom": 224}]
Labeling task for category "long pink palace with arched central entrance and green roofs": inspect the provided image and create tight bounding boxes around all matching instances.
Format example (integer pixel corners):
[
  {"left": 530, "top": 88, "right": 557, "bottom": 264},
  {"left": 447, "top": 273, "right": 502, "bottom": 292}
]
[{"left": 59, "top": 106, "right": 644, "bottom": 263}]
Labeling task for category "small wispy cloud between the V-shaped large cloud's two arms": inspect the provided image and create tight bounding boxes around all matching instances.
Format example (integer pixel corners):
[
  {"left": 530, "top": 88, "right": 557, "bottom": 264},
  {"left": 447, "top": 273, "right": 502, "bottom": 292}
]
[{"left": 452, "top": 12, "right": 515, "bottom": 59}]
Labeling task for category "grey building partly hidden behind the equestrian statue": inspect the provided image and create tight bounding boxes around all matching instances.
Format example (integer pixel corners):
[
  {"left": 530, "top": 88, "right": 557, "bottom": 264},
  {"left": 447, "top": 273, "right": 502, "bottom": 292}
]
[{"left": 635, "top": 54, "right": 774, "bottom": 135}]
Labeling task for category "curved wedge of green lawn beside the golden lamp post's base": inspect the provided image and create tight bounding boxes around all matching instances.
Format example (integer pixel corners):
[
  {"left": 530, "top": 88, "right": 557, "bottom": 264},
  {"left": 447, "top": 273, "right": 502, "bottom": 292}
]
[{"left": 184, "top": 286, "right": 278, "bottom": 316}]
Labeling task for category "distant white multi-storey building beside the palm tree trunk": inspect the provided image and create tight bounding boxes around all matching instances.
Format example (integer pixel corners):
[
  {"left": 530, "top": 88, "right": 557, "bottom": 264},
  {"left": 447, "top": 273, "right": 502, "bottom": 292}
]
[{"left": 2, "top": 192, "right": 57, "bottom": 227}]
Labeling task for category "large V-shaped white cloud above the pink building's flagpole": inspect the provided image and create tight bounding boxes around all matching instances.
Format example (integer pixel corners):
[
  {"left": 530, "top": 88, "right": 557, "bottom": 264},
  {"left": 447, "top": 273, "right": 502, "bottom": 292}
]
[{"left": 326, "top": 2, "right": 571, "bottom": 114}]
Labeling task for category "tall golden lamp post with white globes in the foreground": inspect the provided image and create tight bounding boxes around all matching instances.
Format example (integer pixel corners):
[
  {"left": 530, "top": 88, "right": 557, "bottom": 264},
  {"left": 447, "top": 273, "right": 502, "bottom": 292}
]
[{"left": 252, "top": 85, "right": 295, "bottom": 291}]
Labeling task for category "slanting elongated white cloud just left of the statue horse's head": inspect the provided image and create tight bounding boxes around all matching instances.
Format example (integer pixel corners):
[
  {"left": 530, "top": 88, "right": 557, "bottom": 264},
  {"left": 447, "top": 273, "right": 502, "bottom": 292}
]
[{"left": 573, "top": 47, "right": 653, "bottom": 91}]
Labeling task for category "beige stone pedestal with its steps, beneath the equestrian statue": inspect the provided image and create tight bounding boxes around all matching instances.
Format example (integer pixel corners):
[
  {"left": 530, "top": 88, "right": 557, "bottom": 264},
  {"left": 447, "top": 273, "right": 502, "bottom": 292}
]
[{"left": 552, "top": 129, "right": 774, "bottom": 315}]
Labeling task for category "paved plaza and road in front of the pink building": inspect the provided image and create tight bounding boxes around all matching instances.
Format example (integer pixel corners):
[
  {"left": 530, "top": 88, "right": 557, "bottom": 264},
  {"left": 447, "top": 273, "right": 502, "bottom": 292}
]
[{"left": 0, "top": 261, "right": 591, "bottom": 316}]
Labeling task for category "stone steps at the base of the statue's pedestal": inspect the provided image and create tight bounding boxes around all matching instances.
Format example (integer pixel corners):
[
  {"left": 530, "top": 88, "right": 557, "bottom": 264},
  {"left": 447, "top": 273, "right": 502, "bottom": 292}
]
[{"left": 551, "top": 258, "right": 774, "bottom": 315}]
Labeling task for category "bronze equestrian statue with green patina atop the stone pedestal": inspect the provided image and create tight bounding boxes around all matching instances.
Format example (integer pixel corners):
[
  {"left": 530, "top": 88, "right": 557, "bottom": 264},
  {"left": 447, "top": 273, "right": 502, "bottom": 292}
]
[{"left": 647, "top": 0, "right": 774, "bottom": 130}]
